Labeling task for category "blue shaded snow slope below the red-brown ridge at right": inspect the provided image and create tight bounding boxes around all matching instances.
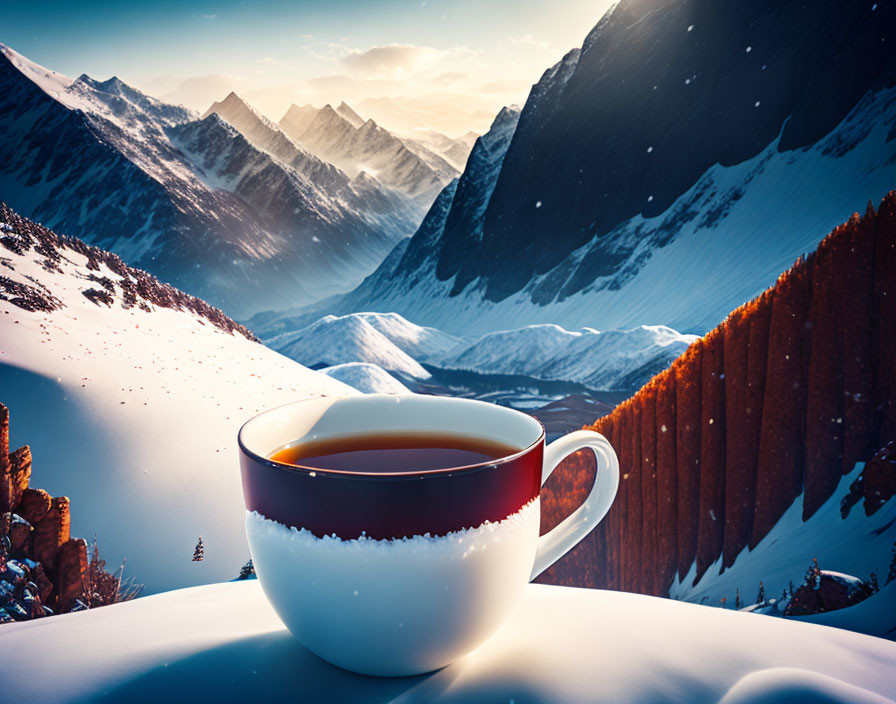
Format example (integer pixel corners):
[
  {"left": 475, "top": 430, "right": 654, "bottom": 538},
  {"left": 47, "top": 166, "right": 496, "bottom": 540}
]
[{"left": 669, "top": 462, "right": 896, "bottom": 638}]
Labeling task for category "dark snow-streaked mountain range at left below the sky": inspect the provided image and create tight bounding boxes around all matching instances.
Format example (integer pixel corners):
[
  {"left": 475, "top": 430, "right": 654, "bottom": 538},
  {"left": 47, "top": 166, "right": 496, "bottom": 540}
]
[{"left": 0, "top": 47, "right": 420, "bottom": 316}]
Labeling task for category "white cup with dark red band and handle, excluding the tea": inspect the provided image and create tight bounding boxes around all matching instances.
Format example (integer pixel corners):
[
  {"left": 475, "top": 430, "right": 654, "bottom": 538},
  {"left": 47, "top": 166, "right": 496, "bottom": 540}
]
[{"left": 239, "top": 394, "right": 619, "bottom": 676}]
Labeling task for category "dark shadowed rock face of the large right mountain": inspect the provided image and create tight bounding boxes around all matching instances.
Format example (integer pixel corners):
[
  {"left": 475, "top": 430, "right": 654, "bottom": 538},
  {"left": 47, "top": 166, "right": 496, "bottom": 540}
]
[{"left": 468, "top": 0, "right": 896, "bottom": 301}]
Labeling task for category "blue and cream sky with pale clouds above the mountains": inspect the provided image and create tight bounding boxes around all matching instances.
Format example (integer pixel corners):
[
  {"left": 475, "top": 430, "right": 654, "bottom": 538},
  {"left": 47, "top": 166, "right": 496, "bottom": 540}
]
[{"left": 0, "top": 0, "right": 611, "bottom": 136}]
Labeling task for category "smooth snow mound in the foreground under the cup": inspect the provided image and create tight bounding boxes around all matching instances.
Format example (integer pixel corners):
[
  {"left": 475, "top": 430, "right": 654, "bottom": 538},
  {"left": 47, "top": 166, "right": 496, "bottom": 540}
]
[{"left": 0, "top": 580, "right": 896, "bottom": 704}]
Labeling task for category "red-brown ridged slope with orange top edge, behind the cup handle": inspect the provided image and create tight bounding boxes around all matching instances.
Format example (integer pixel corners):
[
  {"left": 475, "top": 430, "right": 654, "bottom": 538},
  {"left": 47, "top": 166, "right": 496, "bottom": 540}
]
[{"left": 543, "top": 191, "right": 896, "bottom": 594}]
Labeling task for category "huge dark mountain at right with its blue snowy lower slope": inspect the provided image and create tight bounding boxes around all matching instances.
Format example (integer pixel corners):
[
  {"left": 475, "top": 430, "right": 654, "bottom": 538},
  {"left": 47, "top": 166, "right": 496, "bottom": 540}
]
[{"left": 280, "top": 0, "right": 896, "bottom": 334}]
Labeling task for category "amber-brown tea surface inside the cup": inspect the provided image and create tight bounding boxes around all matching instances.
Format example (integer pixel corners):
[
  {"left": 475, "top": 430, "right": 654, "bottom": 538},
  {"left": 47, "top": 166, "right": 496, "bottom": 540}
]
[{"left": 269, "top": 433, "right": 522, "bottom": 474}]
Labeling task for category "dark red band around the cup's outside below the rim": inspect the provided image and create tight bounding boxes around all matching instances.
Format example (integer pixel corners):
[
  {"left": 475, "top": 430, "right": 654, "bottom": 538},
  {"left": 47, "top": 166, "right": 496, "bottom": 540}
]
[{"left": 240, "top": 436, "right": 544, "bottom": 540}]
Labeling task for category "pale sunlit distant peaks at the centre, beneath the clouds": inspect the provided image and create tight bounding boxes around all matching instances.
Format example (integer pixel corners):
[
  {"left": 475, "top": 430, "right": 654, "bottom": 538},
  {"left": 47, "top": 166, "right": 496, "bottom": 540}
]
[{"left": 280, "top": 102, "right": 458, "bottom": 206}]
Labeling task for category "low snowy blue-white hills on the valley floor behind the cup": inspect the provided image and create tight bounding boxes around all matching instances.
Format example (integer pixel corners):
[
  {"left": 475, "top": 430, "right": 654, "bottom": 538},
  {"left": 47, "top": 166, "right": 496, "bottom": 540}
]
[{"left": 266, "top": 313, "right": 696, "bottom": 391}]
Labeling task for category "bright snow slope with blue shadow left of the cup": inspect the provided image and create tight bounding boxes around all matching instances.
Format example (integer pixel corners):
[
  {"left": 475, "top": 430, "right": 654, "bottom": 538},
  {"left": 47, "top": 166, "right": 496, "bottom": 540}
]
[{"left": 0, "top": 228, "right": 356, "bottom": 593}]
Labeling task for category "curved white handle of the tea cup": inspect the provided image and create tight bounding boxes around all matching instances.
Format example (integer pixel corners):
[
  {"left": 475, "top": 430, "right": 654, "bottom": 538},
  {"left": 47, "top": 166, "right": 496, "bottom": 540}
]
[{"left": 529, "top": 430, "right": 619, "bottom": 581}]
